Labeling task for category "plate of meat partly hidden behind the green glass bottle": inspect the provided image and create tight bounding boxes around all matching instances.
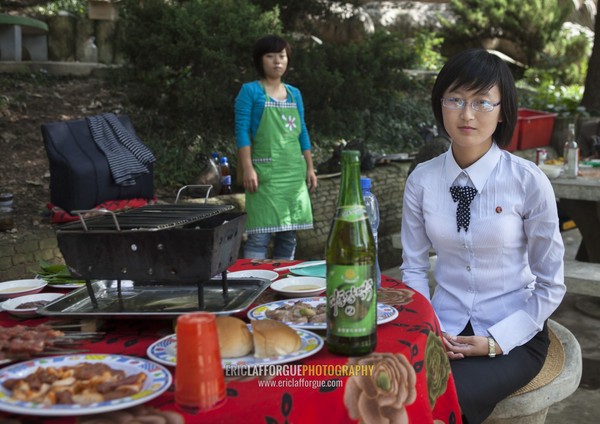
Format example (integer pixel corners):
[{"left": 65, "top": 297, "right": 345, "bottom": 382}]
[{"left": 248, "top": 296, "right": 398, "bottom": 330}]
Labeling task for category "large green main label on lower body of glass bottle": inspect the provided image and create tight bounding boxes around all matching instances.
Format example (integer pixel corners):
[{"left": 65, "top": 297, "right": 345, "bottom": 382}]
[{"left": 327, "top": 265, "right": 377, "bottom": 337}]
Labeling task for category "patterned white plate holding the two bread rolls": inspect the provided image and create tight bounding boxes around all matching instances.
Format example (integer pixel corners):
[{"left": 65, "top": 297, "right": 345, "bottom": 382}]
[{"left": 146, "top": 324, "right": 324, "bottom": 367}]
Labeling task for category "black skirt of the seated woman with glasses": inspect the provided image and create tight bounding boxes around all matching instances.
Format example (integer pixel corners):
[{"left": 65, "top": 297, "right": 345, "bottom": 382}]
[{"left": 450, "top": 322, "right": 550, "bottom": 424}]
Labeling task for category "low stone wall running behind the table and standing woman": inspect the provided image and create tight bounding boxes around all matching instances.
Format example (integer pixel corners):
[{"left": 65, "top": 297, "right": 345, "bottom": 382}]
[{"left": 0, "top": 162, "right": 410, "bottom": 281}]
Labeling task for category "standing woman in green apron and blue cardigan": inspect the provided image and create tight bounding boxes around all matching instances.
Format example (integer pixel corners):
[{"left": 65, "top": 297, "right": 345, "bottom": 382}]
[{"left": 235, "top": 35, "right": 317, "bottom": 259}]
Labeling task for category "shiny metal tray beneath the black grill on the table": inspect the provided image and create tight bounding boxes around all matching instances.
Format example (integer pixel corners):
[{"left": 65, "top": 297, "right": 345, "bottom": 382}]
[{"left": 37, "top": 278, "right": 271, "bottom": 318}]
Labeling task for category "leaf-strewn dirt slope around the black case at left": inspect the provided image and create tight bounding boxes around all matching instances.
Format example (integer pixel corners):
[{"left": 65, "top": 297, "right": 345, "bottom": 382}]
[{"left": 0, "top": 74, "right": 131, "bottom": 238}]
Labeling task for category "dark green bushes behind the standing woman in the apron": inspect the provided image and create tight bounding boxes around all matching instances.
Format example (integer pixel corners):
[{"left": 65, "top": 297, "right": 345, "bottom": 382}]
[{"left": 122, "top": 0, "right": 436, "bottom": 188}]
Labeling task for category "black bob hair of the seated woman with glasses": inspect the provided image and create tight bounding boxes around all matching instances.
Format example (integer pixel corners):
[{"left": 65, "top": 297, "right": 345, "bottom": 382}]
[{"left": 431, "top": 49, "right": 518, "bottom": 147}]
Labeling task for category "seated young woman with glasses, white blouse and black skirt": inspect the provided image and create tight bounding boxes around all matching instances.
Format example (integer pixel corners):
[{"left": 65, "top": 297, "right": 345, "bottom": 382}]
[{"left": 401, "top": 49, "right": 566, "bottom": 424}]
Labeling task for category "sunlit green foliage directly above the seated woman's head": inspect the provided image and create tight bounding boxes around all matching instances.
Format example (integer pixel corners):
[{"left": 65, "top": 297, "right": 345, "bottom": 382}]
[{"left": 441, "top": 0, "right": 573, "bottom": 65}]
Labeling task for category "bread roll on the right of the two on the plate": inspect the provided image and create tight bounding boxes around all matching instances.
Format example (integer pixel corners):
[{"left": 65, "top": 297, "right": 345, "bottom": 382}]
[{"left": 252, "top": 319, "right": 302, "bottom": 358}]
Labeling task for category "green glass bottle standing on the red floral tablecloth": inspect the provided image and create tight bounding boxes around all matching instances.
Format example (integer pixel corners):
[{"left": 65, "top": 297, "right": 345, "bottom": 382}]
[{"left": 325, "top": 150, "right": 377, "bottom": 356}]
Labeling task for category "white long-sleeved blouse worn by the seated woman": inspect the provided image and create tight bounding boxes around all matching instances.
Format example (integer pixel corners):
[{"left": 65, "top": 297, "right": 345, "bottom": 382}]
[{"left": 400, "top": 143, "right": 566, "bottom": 354}]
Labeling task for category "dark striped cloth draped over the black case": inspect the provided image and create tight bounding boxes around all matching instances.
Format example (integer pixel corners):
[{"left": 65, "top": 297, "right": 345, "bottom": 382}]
[{"left": 86, "top": 113, "right": 156, "bottom": 186}]
